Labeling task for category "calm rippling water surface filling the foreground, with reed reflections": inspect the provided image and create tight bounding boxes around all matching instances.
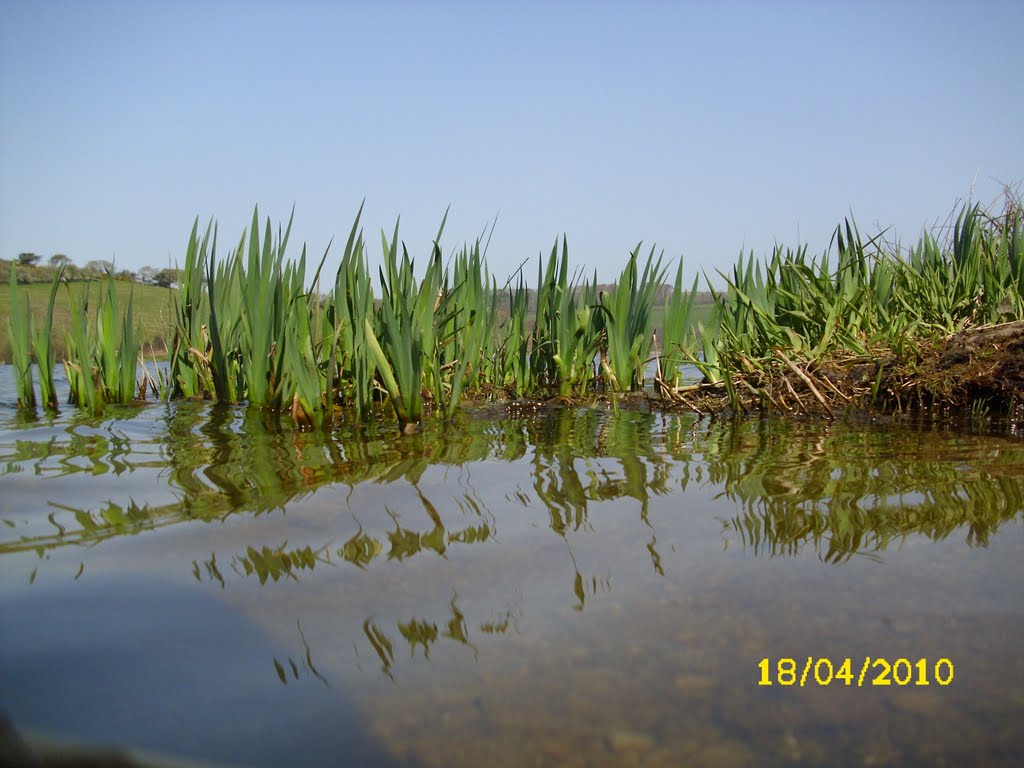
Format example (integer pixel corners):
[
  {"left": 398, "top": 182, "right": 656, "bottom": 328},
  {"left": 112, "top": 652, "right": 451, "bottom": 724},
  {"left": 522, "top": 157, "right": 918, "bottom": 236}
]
[{"left": 0, "top": 368, "right": 1024, "bottom": 767}]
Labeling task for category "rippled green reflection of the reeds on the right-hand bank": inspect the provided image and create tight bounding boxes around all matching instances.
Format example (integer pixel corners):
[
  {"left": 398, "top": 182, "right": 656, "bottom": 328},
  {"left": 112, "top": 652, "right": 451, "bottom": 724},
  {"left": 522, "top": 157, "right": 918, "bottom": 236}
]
[{"left": 709, "top": 421, "right": 1024, "bottom": 562}]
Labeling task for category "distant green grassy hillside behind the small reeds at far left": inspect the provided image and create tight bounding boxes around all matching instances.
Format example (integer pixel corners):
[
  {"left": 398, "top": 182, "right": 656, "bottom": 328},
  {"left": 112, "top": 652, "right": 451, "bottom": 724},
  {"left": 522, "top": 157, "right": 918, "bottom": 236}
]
[{"left": 0, "top": 282, "right": 173, "bottom": 362}]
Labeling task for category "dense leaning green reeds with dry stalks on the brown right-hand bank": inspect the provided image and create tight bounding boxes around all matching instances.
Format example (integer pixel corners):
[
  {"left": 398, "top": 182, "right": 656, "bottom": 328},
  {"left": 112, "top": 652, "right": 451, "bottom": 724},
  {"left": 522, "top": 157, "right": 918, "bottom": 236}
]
[{"left": 668, "top": 198, "right": 1024, "bottom": 414}]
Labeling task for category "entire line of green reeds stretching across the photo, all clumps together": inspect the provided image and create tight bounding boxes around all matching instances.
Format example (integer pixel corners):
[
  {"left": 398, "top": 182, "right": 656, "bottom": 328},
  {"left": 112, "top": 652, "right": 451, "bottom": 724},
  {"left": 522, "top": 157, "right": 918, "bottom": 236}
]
[{"left": 9, "top": 198, "right": 1024, "bottom": 432}]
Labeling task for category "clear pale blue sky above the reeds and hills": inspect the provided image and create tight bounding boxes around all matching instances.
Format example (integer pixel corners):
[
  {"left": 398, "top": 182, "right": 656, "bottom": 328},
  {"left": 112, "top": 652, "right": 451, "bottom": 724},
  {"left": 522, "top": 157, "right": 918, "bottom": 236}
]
[{"left": 0, "top": 0, "right": 1024, "bottom": 288}]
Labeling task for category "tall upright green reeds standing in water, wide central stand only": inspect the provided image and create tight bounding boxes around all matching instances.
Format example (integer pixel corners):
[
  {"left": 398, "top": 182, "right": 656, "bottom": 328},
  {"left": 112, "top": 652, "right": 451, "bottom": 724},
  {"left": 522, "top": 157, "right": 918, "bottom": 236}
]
[{"left": 162, "top": 208, "right": 660, "bottom": 432}]
